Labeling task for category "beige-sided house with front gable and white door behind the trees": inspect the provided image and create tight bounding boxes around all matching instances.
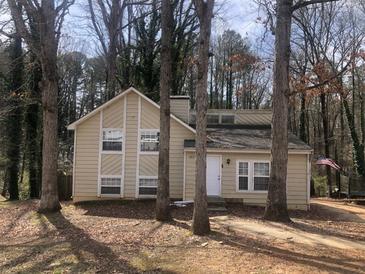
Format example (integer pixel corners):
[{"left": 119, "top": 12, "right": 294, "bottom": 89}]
[{"left": 68, "top": 88, "right": 312, "bottom": 209}]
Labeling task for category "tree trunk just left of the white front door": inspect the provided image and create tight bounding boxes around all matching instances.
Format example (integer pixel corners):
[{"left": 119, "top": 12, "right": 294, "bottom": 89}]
[{"left": 193, "top": 0, "right": 214, "bottom": 235}]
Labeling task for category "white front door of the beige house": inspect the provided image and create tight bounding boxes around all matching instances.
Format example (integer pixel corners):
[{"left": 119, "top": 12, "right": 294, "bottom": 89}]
[{"left": 207, "top": 156, "right": 221, "bottom": 196}]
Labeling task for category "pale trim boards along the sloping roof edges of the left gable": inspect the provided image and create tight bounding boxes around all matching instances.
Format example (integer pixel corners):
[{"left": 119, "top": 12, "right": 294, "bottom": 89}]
[{"left": 67, "top": 87, "right": 196, "bottom": 133}]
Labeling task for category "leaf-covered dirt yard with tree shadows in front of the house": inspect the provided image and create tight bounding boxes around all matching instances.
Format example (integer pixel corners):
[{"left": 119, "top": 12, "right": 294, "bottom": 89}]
[{"left": 0, "top": 200, "right": 365, "bottom": 273}]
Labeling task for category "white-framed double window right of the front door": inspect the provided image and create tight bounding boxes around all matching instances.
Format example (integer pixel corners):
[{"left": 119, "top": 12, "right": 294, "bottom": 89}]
[{"left": 237, "top": 161, "right": 270, "bottom": 191}]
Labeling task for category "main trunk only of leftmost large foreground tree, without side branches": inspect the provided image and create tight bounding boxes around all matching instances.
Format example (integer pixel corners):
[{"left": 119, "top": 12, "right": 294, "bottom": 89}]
[{"left": 39, "top": 1, "right": 61, "bottom": 212}]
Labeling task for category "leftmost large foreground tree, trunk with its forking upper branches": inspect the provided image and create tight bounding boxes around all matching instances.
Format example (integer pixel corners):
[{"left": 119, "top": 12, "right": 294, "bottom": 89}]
[{"left": 8, "top": 0, "right": 73, "bottom": 212}]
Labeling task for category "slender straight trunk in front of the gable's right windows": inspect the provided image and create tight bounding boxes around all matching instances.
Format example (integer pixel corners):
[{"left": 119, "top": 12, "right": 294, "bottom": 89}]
[{"left": 156, "top": 0, "right": 173, "bottom": 221}]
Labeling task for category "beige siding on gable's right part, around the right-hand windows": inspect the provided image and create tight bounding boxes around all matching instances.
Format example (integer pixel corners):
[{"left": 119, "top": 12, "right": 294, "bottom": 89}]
[{"left": 140, "top": 99, "right": 194, "bottom": 199}]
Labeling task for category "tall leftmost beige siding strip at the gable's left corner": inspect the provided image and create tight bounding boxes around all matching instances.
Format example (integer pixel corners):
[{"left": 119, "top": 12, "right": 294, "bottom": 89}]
[{"left": 74, "top": 113, "right": 100, "bottom": 197}]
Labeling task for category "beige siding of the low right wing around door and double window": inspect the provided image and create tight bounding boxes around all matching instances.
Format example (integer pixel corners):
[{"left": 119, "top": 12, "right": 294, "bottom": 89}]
[{"left": 185, "top": 152, "right": 307, "bottom": 208}]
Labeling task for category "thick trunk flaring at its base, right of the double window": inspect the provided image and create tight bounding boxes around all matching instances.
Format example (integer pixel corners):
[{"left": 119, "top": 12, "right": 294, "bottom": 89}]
[{"left": 264, "top": 0, "right": 293, "bottom": 222}]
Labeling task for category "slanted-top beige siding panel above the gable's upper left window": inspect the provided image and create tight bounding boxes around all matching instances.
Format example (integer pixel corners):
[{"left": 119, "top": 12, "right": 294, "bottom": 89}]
[{"left": 103, "top": 98, "right": 124, "bottom": 128}]
